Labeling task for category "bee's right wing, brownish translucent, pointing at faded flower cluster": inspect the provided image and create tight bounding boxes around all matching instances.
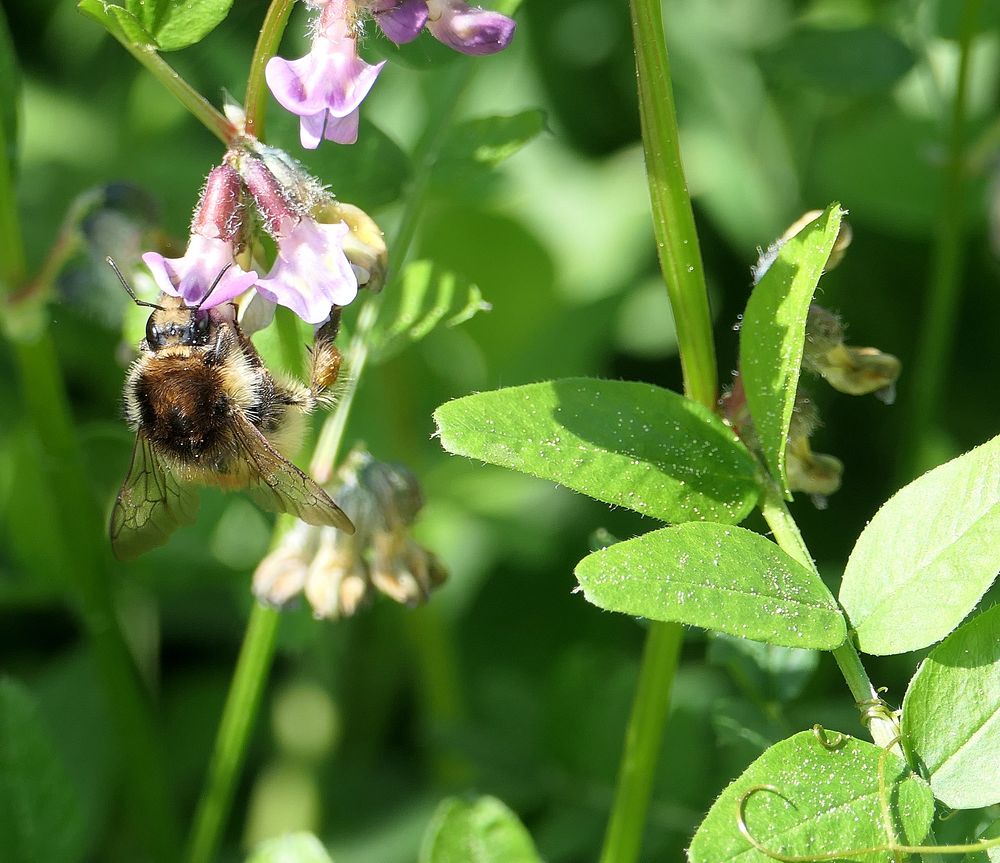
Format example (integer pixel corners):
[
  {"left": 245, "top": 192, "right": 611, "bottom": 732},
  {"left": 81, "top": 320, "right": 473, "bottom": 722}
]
[{"left": 233, "top": 416, "right": 354, "bottom": 533}]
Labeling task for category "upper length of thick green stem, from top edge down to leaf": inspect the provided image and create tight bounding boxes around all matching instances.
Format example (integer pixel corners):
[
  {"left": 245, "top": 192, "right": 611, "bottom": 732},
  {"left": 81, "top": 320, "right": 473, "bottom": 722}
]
[{"left": 631, "top": 0, "right": 718, "bottom": 409}]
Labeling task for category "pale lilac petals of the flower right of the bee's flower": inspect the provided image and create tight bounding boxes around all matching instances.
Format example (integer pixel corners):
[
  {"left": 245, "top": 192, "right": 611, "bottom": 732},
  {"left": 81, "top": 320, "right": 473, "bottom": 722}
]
[{"left": 257, "top": 217, "right": 358, "bottom": 324}]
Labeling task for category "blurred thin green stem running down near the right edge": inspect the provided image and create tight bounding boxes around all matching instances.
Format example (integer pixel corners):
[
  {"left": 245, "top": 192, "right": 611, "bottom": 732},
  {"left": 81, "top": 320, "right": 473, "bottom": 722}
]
[{"left": 900, "top": 0, "right": 983, "bottom": 481}]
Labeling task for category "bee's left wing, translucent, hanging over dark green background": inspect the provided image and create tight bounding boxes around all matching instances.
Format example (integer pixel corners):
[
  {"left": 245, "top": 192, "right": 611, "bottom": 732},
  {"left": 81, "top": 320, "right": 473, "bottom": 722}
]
[{"left": 110, "top": 432, "right": 198, "bottom": 560}]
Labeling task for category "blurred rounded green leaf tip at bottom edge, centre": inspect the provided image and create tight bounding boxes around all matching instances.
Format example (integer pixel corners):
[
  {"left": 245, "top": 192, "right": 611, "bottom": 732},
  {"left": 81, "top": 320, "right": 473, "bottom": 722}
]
[{"left": 420, "top": 797, "right": 541, "bottom": 863}]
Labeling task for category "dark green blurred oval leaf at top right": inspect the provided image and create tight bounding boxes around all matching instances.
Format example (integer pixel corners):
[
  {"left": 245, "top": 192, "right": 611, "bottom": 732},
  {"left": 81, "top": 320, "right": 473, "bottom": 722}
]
[{"left": 761, "top": 27, "right": 916, "bottom": 97}]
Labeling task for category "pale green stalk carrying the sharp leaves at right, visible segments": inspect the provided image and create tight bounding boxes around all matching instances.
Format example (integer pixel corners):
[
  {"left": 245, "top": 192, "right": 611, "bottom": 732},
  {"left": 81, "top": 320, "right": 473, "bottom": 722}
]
[{"left": 760, "top": 488, "right": 899, "bottom": 746}]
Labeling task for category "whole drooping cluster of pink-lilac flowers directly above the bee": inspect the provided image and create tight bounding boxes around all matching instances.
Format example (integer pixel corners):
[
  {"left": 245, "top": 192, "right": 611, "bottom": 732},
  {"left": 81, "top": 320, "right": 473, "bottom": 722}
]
[{"left": 142, "top": 138, "right": 388, "bottom": 324}]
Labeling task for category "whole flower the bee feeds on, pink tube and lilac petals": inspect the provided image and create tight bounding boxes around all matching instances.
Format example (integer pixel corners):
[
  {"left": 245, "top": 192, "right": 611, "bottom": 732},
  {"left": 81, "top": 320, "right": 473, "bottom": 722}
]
[{"left": 142, "top": 165, "right": 257, "bottom": 309}]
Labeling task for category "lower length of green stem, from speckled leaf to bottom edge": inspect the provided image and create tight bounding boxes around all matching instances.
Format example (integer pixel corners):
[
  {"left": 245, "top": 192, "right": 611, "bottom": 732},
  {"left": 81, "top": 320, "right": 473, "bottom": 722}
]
[{"left": 600, "top": 623, "right": 683, "bottom": 863}]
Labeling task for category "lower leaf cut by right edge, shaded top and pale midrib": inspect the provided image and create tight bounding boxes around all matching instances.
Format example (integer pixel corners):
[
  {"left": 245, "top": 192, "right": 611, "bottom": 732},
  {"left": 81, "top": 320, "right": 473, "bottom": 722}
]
[{"left": 902, "top": 606, "right": 1000, "bottom": 809}]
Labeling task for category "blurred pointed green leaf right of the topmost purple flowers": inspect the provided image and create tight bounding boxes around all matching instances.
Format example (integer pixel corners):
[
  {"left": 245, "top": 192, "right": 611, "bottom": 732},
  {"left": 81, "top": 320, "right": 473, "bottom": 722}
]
[{"left": 431, "top": 110, "right": 545, "bottom": 189}]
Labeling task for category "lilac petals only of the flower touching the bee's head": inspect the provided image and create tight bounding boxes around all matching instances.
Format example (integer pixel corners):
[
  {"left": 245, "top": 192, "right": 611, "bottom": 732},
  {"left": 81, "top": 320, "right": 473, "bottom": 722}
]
[{"left": 142, "top": 234, "right": 257, "bottom": 309}]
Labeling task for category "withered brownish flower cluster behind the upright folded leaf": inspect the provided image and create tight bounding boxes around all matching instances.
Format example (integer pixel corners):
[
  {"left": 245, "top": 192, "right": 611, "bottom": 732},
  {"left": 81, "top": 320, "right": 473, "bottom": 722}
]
[{"left": 719, "top": 210, "right": 901, "bottom": 509}]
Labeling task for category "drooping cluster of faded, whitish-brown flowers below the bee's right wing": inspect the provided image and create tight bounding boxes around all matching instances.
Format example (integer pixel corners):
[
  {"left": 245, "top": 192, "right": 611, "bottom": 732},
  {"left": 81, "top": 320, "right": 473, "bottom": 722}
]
[{"left": 253, "top": 449, "right": 445, "bottom": 618}]
